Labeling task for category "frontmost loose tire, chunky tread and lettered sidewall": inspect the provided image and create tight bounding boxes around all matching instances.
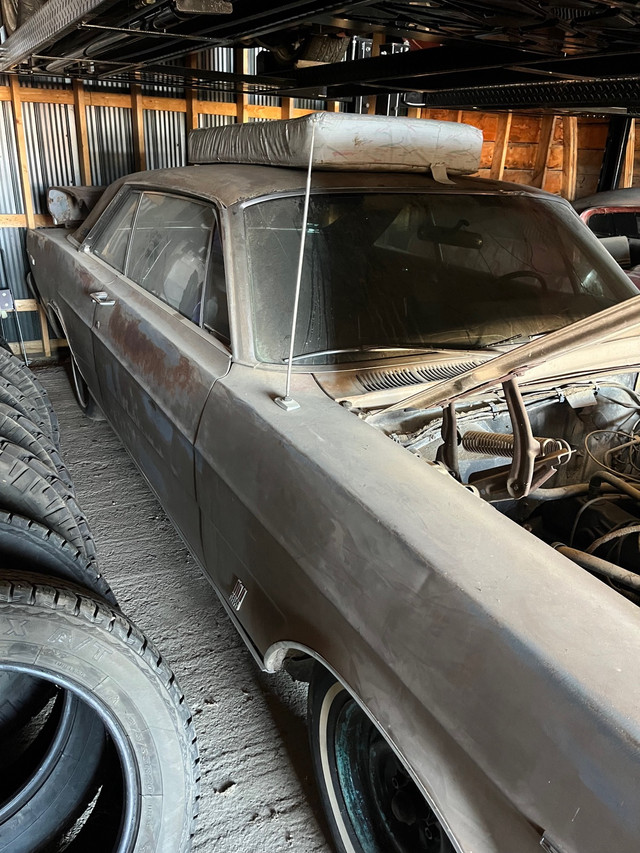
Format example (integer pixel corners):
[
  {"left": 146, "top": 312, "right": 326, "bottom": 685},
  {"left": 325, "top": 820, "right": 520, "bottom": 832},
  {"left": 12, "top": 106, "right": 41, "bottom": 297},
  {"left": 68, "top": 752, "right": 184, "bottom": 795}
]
[{"left": 0, "top": 573, "right": 199, "bottom": 853}]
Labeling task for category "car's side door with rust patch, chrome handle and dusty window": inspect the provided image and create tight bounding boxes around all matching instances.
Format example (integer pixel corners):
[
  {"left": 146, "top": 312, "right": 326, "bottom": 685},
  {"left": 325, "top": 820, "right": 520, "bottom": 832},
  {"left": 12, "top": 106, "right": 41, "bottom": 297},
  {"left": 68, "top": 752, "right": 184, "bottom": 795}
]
[{"left": 88, "top": 189, "right": 230, "bottom": 555}]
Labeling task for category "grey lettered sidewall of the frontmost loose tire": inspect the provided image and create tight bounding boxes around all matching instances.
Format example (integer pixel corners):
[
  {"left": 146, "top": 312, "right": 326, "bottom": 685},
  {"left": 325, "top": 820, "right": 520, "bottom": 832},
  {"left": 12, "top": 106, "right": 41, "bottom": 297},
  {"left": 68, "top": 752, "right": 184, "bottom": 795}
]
[{"left": 0, "top": 583, "right": 197, "bottom": 853}]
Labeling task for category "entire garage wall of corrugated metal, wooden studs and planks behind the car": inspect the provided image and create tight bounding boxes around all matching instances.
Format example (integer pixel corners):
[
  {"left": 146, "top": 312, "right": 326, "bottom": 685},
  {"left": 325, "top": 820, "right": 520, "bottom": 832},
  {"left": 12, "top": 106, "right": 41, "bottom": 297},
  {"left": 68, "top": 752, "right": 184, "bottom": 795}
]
[{"left": 0, "top": 48, "right": 640, "bottom": 356}]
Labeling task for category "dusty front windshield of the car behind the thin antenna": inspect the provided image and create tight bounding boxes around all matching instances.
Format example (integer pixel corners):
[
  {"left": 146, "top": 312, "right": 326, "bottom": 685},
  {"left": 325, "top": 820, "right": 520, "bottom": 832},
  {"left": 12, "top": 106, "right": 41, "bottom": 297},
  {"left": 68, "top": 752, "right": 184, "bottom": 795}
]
[{"left": 244, "top": 193, "right": 637, "bottom": 365}]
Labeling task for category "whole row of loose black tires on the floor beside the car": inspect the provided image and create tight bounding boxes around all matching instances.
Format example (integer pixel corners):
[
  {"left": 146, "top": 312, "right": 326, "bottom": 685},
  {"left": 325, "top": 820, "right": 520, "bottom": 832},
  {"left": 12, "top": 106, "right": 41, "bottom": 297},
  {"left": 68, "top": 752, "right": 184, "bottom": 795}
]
[{"left": 0, "top": 348, "right": 198, "bottom": 853}]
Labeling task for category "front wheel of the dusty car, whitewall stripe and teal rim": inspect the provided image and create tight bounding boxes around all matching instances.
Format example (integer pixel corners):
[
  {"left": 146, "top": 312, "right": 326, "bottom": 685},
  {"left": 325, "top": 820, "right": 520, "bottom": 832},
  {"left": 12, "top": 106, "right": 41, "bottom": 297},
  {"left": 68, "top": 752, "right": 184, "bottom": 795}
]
[{"left": 309, "top": 664, "right": 455, "bottom": 853}]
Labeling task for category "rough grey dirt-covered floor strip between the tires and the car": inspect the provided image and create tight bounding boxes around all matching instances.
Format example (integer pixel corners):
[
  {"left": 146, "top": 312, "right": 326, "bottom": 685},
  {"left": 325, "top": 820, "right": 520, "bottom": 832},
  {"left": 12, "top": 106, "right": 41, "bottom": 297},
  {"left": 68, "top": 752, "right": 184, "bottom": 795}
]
[{"left": 35, "top": 365, "right": 331, "bottom": 853}]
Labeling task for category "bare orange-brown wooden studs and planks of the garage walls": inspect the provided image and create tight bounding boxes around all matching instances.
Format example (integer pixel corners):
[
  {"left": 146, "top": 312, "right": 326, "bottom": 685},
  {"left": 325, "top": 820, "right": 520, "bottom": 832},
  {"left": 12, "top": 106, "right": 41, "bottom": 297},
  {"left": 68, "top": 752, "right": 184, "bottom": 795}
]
[{"left": 0, "top": 62, "right": 628, "bottom": 352}]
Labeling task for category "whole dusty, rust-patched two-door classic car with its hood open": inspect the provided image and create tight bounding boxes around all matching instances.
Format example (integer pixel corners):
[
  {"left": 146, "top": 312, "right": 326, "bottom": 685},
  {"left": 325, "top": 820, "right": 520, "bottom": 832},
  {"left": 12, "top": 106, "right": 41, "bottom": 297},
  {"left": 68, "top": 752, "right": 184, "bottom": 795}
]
[{"left": 27, "top": 118, "right": 640, "bottom": 853}]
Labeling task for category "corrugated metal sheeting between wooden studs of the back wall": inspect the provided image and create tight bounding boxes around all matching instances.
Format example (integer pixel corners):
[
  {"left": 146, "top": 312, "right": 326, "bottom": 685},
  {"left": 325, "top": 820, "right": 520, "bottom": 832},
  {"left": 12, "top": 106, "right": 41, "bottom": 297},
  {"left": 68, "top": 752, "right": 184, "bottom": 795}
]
[{"left": 0, "top": 48, "right": 344, "bottom": 340}]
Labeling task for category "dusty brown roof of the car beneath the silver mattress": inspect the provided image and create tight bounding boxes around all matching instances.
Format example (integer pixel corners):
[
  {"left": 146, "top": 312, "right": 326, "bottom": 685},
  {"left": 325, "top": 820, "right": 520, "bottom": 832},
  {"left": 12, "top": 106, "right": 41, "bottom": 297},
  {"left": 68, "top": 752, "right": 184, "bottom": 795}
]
[{"left": 74, "top": 163, "right": 558, "bottom": 242}]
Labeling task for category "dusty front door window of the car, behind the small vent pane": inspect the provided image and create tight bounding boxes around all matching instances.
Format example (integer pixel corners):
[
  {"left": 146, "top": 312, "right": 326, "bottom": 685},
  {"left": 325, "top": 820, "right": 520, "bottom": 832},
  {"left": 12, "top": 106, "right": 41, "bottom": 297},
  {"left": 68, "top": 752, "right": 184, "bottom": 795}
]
[{"left": 126, "top": 193, "right": 215, "bottom": 324}]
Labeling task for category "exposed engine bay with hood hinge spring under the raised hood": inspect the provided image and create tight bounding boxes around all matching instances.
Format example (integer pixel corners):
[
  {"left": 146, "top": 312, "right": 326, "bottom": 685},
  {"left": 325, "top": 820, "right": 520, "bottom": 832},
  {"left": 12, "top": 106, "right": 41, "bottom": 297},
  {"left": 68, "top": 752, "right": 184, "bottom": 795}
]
[{"left": 366, "top": 373, "right": 640, "bottom": 604}]
